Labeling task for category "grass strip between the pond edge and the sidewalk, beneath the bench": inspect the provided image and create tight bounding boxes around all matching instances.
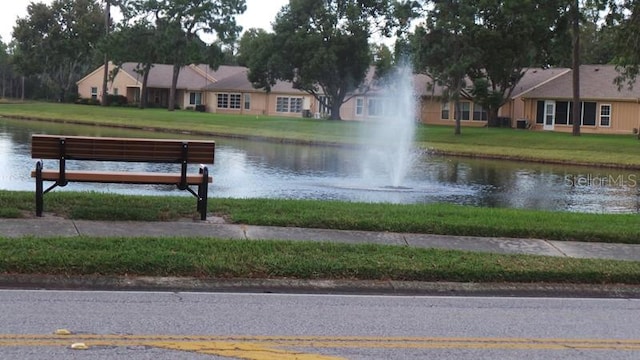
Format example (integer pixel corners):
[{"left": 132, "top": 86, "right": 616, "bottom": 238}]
[{"left": 5, "top": 191, "right": 640, "bottom": 244}]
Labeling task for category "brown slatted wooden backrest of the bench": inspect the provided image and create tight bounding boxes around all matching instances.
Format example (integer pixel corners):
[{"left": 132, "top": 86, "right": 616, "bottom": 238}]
[{"left": 31, "top": 135, "right": 215, "bottom": 164}]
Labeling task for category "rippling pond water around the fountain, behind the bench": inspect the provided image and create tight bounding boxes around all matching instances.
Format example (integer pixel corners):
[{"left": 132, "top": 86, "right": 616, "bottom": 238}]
[{"left": 0, "top": 118, "right": 640, "bottom": 213}]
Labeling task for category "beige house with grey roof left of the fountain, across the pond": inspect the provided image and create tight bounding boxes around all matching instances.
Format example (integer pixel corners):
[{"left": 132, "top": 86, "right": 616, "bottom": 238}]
[{"left": 77, "top": 63, "right": 320, "bottom": 117}]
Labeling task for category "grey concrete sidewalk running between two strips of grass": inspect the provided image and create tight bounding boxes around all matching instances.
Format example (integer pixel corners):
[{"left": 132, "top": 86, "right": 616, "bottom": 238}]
[{"left": 0, "top": 216, "right": 640, "bottom": 261}]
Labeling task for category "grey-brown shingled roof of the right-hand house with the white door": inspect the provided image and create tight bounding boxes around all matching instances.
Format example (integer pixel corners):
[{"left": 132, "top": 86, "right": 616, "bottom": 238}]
[{"left": 522, "top": 65, "right": 640, "bottom": 101}]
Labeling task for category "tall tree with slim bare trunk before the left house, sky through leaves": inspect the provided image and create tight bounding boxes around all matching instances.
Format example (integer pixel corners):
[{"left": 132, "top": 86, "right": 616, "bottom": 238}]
[{"left": 126, "top": 0, "right": 246, "bottom": 111}]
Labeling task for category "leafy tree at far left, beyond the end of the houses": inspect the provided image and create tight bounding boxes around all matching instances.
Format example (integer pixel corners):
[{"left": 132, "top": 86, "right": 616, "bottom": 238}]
[{"left": 13, "top": 0, "right": 104, "bottom": 101}]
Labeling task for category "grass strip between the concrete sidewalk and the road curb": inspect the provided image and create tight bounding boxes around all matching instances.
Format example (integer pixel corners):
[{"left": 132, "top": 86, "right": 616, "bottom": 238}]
[{"left": 0, "top": 238, "right": 640, "bottom": 284}]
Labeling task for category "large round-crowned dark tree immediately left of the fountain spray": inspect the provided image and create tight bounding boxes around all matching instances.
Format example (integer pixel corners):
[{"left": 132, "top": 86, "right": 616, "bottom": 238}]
[{"left": 248, "top": 0, "right": 390, "bottom": 120}]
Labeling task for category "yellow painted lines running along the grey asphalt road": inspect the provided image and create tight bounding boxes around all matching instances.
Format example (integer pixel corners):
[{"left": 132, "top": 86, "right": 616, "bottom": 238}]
[{"left": 0, "top": 334, "right": 640, "bottom": 352}]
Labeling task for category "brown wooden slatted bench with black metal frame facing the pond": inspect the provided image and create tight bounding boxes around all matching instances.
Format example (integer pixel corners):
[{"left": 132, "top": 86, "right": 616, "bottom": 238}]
[{"left": 31, "top": 135, "right": 215, "bottom": 220}]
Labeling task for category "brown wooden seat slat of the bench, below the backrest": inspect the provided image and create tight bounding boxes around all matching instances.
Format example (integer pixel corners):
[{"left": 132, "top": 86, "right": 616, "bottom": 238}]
[{"left": 31, "top": 170, "right": 213, "bottom": 185}]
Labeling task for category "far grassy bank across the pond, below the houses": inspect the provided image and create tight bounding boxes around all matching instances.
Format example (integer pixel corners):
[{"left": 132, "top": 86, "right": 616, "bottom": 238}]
[{"left": 0, "top": 103, "right": 640, "bottom": 169}]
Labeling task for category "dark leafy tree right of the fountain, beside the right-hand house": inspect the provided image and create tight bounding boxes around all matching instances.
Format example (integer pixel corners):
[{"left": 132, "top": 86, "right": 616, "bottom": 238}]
[{"left": 467, "top": 0, "right": 568, "bottom": 129}]
